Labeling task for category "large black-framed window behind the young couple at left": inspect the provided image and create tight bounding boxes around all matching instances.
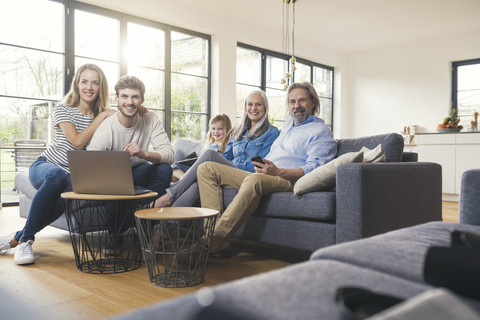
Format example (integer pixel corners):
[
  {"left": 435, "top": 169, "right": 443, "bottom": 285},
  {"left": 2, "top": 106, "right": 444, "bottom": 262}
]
[{"left": 0, "top": 0, "right": 211, "bottom": 202}]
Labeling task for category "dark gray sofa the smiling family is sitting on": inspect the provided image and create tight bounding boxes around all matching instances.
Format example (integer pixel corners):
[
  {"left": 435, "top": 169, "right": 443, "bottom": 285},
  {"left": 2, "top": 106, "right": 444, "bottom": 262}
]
[{"left": 15, "top": 133, "right": 442, "bottom": 252}]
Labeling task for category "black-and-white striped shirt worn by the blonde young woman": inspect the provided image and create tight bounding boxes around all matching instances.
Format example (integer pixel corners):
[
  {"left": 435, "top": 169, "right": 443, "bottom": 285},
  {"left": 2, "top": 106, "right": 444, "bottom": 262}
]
[{"left": 41, "top": 104, "right": 94, "bottom": 173}]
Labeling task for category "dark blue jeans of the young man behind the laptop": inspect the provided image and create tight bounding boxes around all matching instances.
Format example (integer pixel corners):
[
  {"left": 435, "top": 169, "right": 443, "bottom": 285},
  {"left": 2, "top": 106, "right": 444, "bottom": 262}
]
[{"left": 106, "top": 163, "right": 172, "bottom": 234}]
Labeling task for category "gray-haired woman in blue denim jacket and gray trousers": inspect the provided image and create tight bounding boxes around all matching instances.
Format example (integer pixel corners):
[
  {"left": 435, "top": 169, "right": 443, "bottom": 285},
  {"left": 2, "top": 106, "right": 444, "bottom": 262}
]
[{"left": 155, "top": 90, "right": 280, "bottom": 207}]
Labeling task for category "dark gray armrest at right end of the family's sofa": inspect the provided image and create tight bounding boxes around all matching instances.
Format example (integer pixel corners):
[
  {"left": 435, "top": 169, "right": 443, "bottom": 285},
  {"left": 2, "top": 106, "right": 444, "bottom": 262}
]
[{"left": 336, "top": 162, "right": 442, "bottom": 243}]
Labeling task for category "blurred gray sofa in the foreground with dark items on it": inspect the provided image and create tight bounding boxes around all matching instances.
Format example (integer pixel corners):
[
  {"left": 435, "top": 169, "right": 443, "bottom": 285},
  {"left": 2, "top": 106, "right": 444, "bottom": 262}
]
[{"left": 109, "top": 170, "right": 480, "bottom": 320}]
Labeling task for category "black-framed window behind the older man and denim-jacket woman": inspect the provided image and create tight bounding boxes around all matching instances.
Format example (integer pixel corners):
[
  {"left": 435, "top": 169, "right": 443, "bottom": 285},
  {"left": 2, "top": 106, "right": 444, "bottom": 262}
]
[{"left": 237, "top": 43, "right": 333, "bottom": 129}]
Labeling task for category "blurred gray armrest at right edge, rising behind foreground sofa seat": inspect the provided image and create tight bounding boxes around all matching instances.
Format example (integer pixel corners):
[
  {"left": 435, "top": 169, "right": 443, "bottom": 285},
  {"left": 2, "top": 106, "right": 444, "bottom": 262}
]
[{"left": 460, "top": 169, "right": 480, "bottom": 225}]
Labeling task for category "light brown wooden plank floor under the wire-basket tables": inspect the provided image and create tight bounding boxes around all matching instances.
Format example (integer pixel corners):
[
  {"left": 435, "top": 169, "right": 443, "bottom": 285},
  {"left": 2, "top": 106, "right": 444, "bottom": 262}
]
[{"left": 0, "top": 202, "right": 458, "bottom": 319}]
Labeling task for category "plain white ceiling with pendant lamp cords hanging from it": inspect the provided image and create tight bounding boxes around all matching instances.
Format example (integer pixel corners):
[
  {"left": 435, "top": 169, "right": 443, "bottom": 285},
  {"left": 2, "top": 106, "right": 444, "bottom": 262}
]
[{"left": 176, "top": 0, "right": 480, "bottom": 53}]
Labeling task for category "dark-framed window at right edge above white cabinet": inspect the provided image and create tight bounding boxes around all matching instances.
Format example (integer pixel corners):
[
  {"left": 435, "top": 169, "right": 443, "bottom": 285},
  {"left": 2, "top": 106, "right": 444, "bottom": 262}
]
[{"left": 452, "top": 59, "right": 480, "bottom": 128}]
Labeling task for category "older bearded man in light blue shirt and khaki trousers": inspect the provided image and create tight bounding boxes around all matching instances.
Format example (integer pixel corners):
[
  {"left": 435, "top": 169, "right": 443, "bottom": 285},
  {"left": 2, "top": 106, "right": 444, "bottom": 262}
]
[{"left": 197, "top": 82, "right": 337, "bottom": 253}]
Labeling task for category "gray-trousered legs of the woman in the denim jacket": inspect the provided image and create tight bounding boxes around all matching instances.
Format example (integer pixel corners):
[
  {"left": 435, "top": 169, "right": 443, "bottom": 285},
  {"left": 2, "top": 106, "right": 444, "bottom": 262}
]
[{"left": 155, "top": 149, "right": 235, "bottom": 207}]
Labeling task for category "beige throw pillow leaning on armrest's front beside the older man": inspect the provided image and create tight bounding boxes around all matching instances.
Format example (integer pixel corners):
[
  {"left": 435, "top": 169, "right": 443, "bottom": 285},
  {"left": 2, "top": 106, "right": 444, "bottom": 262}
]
[{"left": 293, "top": 151, "right": 363, "bottom": 195}]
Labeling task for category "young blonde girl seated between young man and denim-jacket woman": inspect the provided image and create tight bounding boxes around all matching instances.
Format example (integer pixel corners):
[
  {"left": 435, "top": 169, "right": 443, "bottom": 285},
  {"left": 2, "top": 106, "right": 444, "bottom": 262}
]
[{"left": 172, "top": 114, "right": 232, "bottom": 182}]
